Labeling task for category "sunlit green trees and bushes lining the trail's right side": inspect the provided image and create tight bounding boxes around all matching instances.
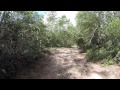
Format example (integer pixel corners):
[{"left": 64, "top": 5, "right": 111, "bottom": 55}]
[{"left": 76, "top": 11, "right": 120, "bottom": 64}]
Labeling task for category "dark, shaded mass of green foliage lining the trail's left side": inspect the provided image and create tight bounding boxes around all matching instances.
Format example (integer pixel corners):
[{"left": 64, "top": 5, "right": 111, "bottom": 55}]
[{"left": 0, "top": 11, "right": 45, "bottom": 78}]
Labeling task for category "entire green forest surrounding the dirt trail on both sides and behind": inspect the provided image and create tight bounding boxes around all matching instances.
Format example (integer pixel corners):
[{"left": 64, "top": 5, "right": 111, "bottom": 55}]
[{"left": 0, "top": 11, "right": 120, "bottom": 79}]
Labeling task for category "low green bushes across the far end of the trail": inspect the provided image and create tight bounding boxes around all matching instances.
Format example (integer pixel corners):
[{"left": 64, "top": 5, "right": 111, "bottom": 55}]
[{"left": 46, "top": 30, "right": 75, "bottom": 47}]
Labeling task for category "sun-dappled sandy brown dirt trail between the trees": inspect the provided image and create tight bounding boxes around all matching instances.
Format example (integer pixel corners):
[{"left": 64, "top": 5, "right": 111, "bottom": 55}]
[{"left": 16, "top": 47, "right": 120, "bottom": 79}]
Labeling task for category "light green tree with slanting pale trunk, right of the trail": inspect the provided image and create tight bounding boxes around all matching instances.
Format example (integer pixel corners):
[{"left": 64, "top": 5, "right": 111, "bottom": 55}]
[{"left": 76, "top": 12, "right": 101, "bottom": 44}]
